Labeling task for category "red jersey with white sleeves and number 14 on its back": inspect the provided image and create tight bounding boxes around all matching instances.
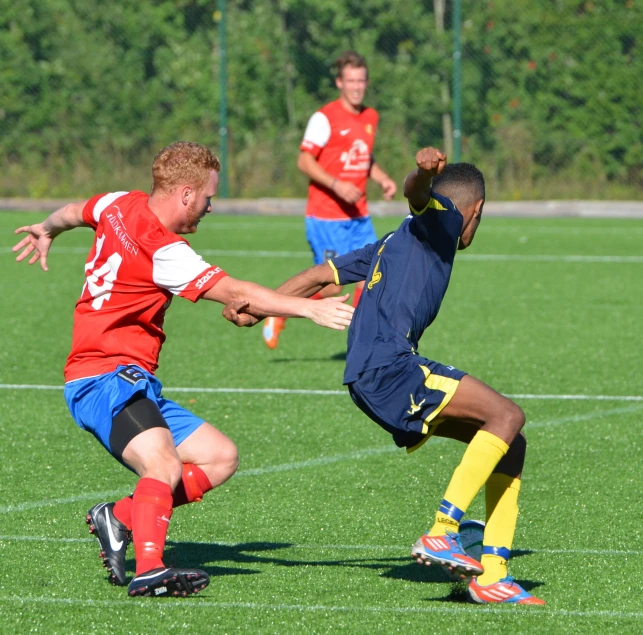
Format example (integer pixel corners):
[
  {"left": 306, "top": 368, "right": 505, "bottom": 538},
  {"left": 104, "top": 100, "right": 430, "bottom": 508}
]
[{"left": 65, "top": 192, "right": 227, "bottom": 381}]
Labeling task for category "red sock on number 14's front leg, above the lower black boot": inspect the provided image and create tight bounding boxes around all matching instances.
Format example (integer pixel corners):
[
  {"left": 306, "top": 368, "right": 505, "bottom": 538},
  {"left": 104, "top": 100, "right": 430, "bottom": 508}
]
[{"left": 132, "top": 478, "right": 172, "bottom": 575}]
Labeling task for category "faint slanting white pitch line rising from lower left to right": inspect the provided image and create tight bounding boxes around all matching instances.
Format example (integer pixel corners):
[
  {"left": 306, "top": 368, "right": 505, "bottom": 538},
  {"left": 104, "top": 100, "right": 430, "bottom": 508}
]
[{"left": 0, "top": 406, "right": 641, "bottom": 514}]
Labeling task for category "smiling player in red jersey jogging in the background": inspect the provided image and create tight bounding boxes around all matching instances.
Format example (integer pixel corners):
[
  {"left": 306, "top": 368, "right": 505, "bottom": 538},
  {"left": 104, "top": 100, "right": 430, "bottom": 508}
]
[{"left": 263, "top": 51, "right": 397, "bottom": 348}]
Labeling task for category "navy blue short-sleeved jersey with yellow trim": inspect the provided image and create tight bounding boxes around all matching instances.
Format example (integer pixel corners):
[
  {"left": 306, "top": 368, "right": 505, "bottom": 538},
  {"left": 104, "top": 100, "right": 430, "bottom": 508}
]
[{"left": 329, "top": 192, "right": 463, "bottom": 384}]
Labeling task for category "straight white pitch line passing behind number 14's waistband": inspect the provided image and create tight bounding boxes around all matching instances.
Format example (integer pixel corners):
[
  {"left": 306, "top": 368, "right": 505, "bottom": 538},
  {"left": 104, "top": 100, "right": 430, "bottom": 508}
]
[{"left": 0, "top": 384, "right": 643, "bottom": 401}]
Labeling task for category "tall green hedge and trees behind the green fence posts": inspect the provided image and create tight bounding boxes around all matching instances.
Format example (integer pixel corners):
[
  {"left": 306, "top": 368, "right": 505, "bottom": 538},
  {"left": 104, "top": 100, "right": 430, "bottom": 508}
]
[{"left": 0, "top": 0, "right": 643, "bottom": 200}]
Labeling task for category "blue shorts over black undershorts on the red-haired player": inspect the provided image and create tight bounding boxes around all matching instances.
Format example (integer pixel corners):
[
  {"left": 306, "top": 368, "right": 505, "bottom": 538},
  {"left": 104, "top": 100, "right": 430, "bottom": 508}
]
[{"left": 65, "top": 366, "right": 204, "bottom": 460}]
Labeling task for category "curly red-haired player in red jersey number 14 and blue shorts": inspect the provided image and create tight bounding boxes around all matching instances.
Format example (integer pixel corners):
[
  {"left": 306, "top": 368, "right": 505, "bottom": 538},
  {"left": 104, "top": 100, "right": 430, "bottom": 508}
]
[{"left": 13, "top": 142, "right": 353, "bottom": 596}]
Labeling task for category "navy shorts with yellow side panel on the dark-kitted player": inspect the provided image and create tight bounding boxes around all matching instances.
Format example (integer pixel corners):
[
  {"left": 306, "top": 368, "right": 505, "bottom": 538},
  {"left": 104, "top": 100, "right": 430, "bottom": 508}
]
[{"left": 348, "top": 355, "right": 466, "bottom": 452}]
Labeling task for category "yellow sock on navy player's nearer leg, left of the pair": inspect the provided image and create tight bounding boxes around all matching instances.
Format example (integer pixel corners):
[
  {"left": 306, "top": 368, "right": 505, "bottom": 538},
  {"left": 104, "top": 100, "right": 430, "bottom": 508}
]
[{"left": 429, "top": 430, "right": 509, "bottom": 536}]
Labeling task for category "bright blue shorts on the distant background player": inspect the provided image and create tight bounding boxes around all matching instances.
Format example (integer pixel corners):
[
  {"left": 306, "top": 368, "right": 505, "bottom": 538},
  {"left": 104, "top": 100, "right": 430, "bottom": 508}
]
[{"left": 306, "top": 216, "right": 377, "bottom": 265}]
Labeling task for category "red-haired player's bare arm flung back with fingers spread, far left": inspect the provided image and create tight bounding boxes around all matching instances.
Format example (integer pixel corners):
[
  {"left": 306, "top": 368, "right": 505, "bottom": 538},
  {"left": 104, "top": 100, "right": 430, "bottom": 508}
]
[{"left": 11, "top": 201, "right": 89, "bottom": 271}]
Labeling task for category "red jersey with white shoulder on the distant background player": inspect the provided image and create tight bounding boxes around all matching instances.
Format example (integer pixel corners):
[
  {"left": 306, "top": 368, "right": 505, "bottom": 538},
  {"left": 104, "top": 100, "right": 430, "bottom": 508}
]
[{"left": 299, "top": 99, "right": 379, "bottom": 220}]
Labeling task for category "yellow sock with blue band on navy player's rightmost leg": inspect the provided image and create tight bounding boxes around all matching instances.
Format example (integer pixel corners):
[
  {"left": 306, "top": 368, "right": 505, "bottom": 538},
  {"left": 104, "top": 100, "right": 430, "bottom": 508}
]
[{"left": 478, "top": 472, "right": 520, "bottom": 585}]
